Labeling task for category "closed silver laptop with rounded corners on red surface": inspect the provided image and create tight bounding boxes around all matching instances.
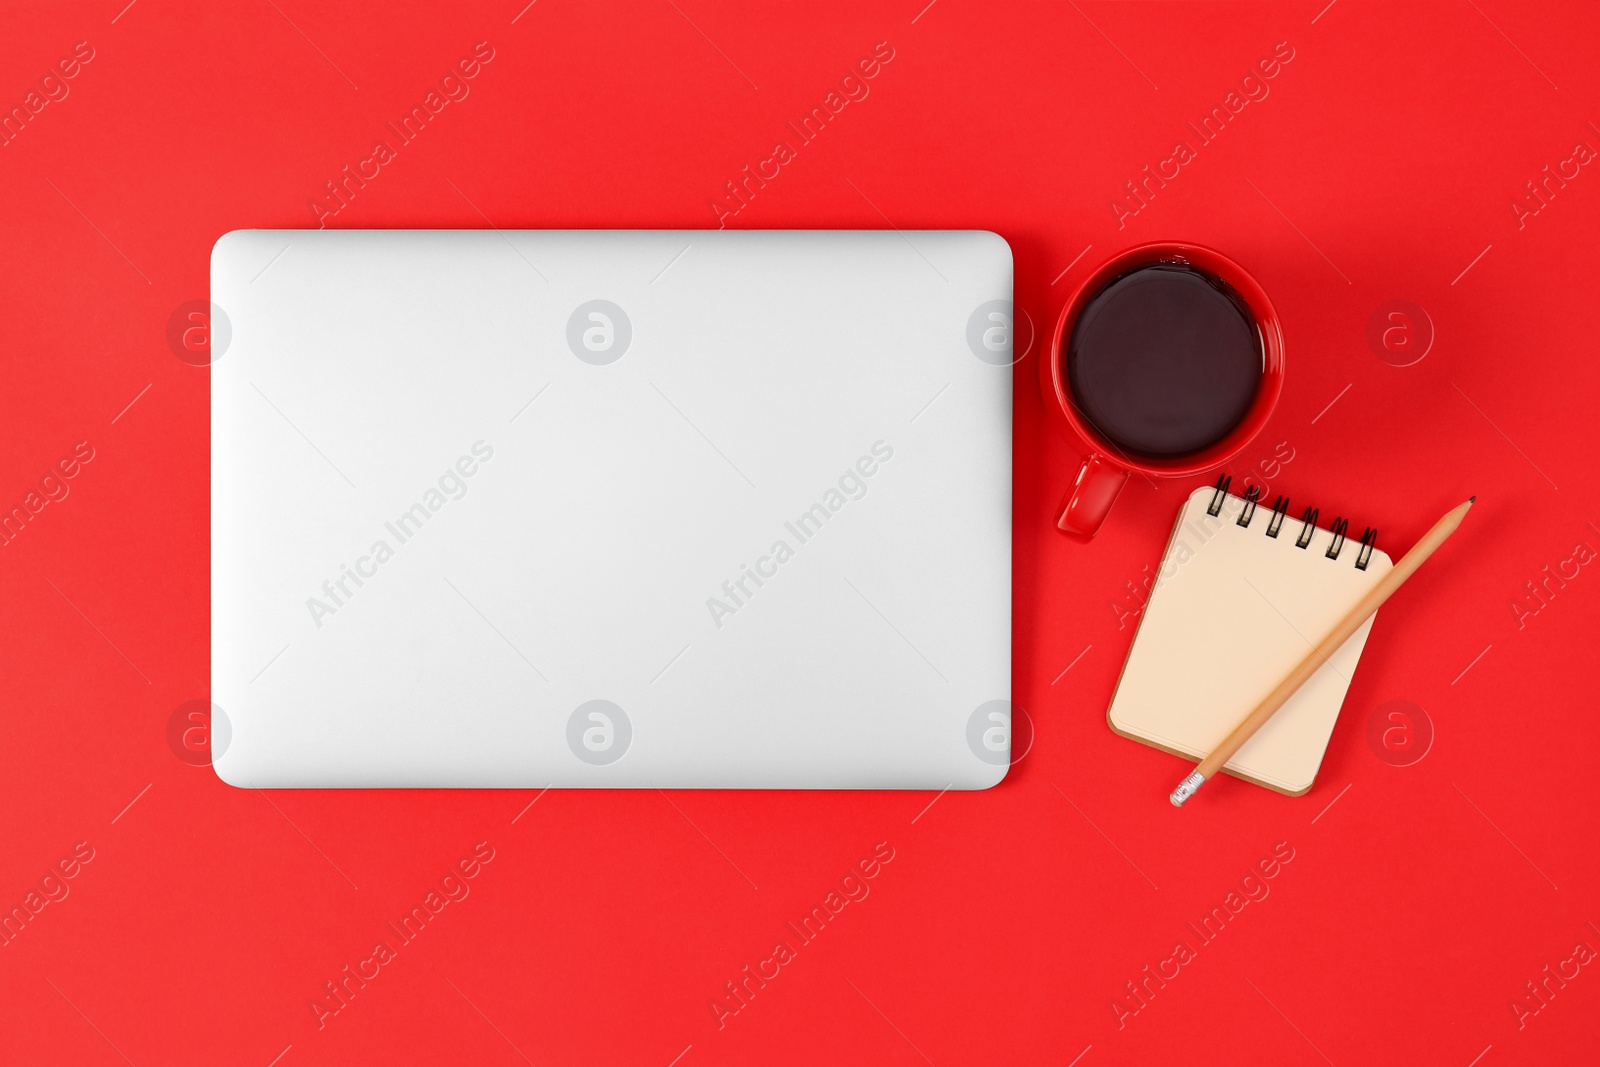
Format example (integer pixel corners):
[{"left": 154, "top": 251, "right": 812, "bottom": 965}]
[{"left": 211, "top": 230, "right": 1013, "bottom": 789}]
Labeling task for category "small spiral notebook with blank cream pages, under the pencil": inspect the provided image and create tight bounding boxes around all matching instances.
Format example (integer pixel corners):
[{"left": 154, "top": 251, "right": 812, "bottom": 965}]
[{"left": 1107, "top": 478, "right": 1392, "bottom": 797}]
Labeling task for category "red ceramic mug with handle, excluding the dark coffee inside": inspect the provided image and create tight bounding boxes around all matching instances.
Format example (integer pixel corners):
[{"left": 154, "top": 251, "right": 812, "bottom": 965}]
[{"left": 1038, "top": 242, "right": 1283, "bottom": 541}]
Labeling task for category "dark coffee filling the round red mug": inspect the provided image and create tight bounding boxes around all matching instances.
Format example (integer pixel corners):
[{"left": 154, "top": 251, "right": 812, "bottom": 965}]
[{"left": 1064, "top": 262, "right": 1264, "bottom": 456}]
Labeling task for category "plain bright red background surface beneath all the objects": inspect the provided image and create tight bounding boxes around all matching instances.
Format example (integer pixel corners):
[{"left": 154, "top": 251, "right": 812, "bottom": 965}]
[{"left": 0, "top": 0, "right": 1600, "bottom": 1067}]
